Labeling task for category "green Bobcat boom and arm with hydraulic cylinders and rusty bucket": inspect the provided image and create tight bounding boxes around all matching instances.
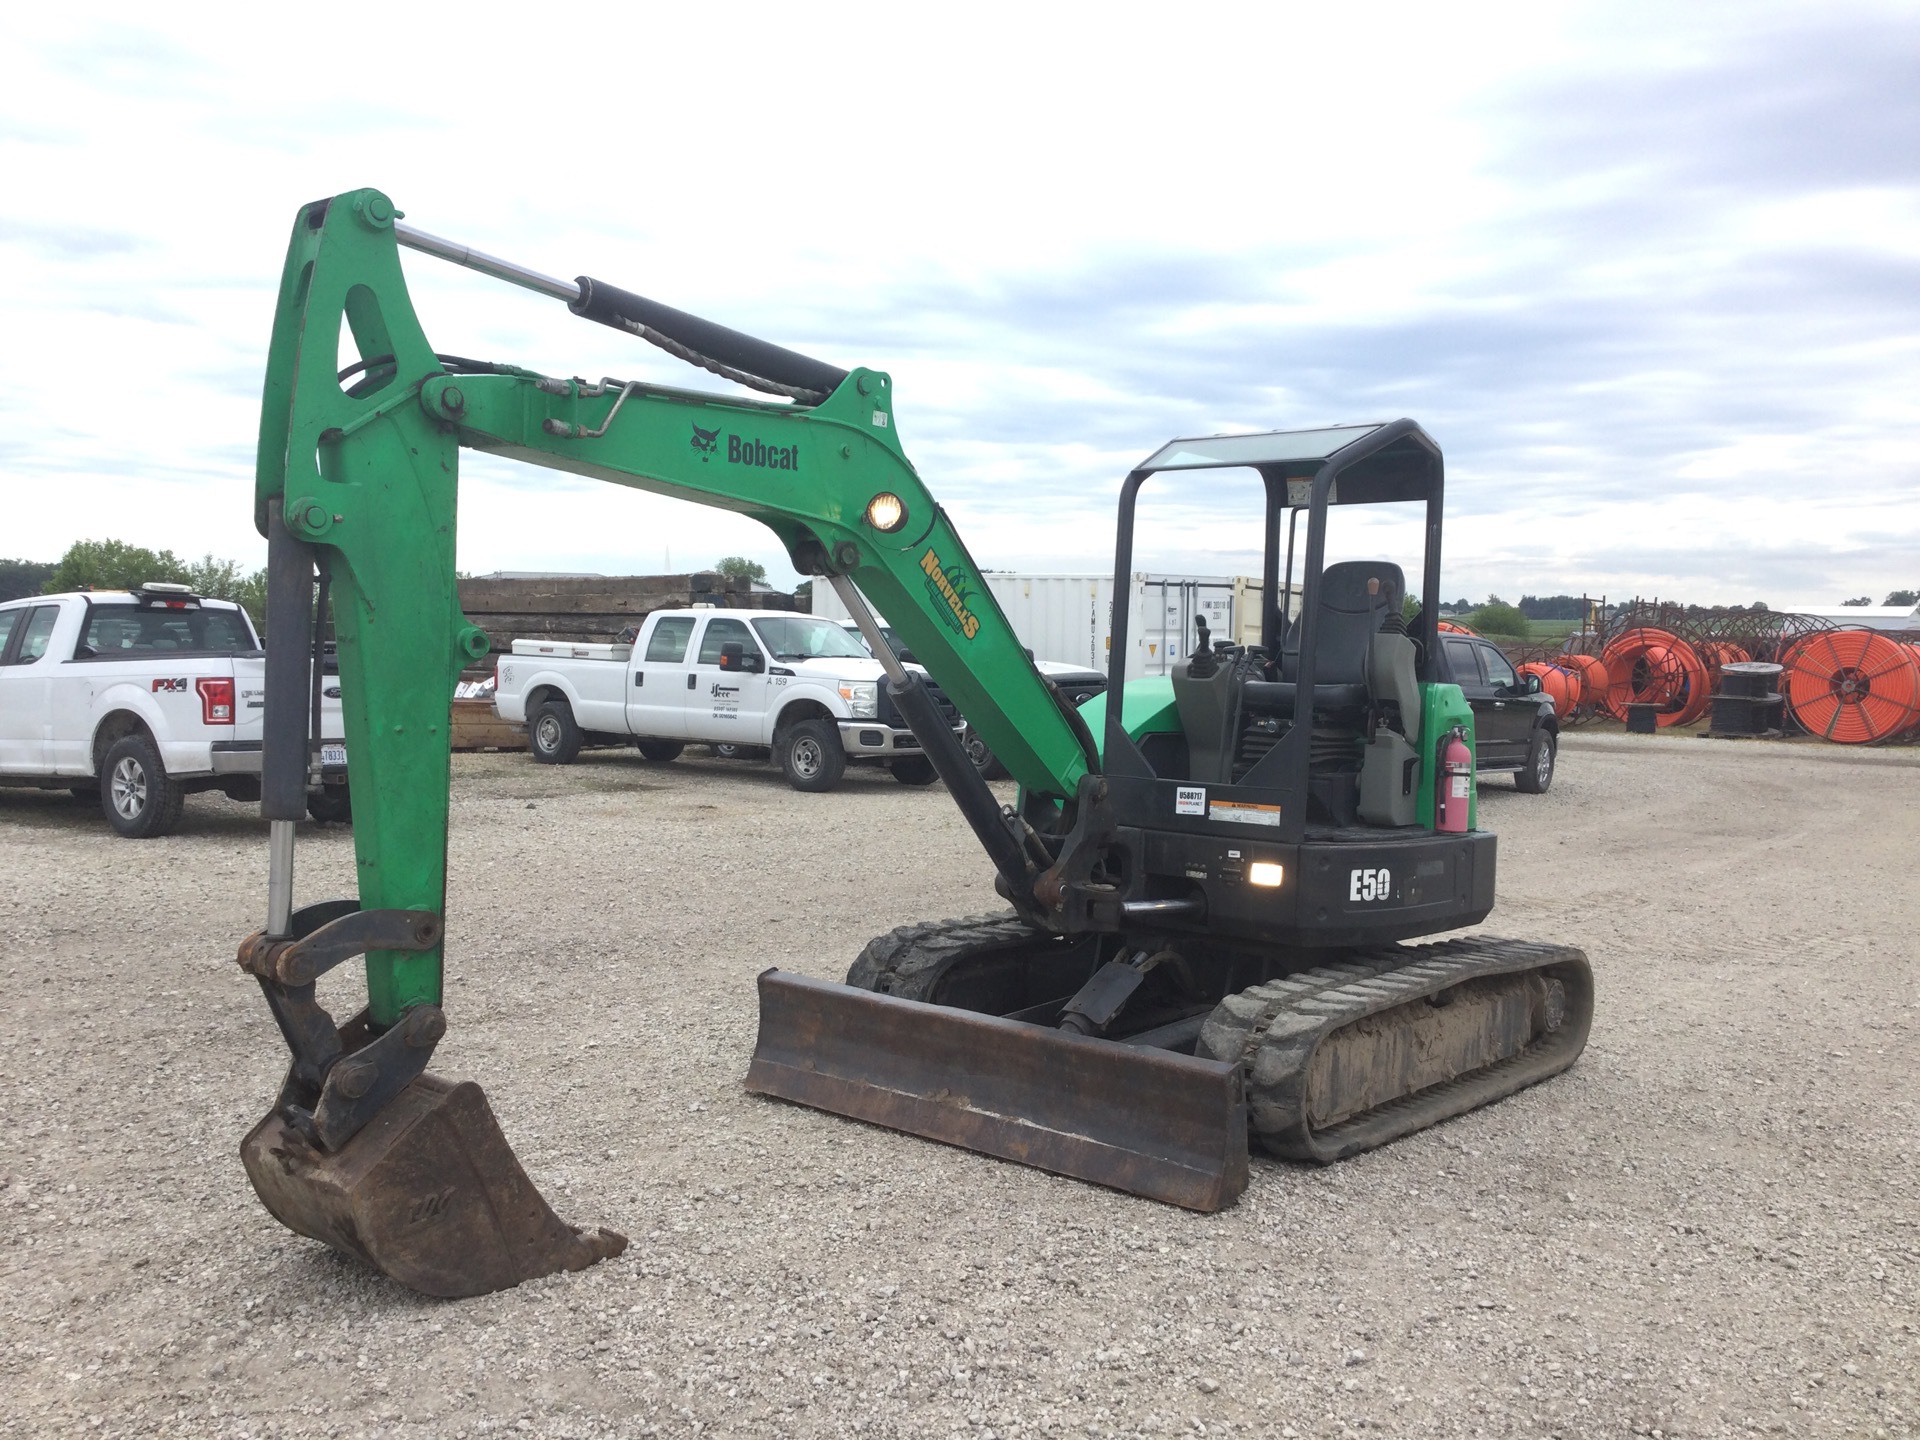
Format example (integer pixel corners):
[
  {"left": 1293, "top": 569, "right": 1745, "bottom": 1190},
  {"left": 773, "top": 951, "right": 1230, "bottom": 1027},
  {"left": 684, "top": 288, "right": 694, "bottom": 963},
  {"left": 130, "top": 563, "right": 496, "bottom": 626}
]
[{"left": 240, "top": 190, "right": 1098, "bottom": 1294}]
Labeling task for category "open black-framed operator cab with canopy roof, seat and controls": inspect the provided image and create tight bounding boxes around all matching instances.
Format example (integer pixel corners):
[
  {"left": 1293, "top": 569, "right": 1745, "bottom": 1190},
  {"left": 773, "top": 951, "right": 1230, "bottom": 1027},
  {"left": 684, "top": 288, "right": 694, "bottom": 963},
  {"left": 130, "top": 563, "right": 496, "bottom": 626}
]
[{"left": 1102, "top": 420, "right": 1442, "bottom": 841}]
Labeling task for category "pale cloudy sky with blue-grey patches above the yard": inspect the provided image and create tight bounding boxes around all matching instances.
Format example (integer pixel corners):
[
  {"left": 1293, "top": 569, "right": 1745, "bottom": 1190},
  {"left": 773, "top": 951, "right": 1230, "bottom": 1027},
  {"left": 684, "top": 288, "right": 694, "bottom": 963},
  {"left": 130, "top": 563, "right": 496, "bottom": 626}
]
[{"left": 0, "top": 0, "right": 1920, "bottom": 605}]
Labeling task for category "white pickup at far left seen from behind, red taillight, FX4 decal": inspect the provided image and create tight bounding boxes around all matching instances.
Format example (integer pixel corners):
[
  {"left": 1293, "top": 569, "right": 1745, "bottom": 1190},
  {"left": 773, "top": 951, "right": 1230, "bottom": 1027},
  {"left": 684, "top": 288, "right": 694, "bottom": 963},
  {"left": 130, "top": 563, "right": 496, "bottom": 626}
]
[{"left": 0, "top": 586, "right": 348, "bottom": 839}]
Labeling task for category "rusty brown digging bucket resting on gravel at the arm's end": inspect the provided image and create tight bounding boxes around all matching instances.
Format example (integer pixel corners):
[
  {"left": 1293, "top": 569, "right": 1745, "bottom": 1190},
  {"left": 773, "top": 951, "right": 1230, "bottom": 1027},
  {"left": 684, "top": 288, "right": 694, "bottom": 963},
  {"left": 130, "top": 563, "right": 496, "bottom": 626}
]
[{"left": 240, "top": 1075, "right": 626, "bottom": 1298}]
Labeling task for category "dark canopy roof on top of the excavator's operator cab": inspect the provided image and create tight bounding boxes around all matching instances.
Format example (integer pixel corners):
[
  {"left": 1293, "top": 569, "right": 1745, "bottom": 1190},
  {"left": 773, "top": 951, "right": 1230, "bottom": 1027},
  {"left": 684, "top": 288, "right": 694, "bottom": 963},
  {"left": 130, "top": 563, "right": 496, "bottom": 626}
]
[{"left": 1137, "top": 420, "right": 1442, "bottom": 505}]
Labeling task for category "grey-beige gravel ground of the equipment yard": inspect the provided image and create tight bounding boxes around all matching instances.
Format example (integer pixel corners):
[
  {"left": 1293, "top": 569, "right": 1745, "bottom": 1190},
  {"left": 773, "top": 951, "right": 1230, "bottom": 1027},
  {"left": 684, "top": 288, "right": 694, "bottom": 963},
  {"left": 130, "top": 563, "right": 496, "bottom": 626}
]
[{"left": 0, "top": 735, "right": 1920, "bottom": 1440}]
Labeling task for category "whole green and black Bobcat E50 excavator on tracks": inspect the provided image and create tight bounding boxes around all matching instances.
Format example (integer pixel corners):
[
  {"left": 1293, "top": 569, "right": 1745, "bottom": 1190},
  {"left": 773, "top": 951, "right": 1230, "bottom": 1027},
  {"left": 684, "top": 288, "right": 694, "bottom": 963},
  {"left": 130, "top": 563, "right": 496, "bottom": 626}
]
[{"left": 240, "top": 190, "right": 1594, "bottom": 1296}]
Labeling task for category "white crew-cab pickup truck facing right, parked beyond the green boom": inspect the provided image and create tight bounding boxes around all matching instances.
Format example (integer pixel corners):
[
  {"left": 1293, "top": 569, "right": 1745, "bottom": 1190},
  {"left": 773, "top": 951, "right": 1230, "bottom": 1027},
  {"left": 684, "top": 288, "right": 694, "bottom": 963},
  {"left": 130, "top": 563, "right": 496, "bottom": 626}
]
[{"left": 493, "top": 609, "right": 960, "bottom": 791}]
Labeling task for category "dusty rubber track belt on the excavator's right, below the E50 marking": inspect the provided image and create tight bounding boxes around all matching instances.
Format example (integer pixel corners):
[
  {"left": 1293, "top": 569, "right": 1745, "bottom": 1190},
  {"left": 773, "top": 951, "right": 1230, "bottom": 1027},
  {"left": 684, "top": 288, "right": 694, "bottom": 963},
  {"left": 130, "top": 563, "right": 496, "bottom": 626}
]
[{"left": 1198, "top": 935, "right": 1594, "bottom": 1165}]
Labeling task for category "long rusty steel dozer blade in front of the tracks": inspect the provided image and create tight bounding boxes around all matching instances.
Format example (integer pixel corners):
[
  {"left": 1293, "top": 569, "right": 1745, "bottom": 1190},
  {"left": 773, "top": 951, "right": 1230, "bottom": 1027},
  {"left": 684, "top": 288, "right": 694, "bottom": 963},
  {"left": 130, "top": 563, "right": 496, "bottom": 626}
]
[{"left": 747, "top": 970, "right": 1246, "bottom": 1212}]
